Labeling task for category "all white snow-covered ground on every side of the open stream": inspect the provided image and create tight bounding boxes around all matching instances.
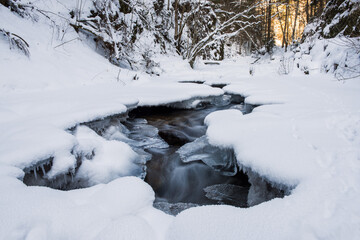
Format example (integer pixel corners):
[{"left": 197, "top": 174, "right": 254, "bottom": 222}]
[{"left": 0, "top": 1, "right": 360, "bottom": 239}]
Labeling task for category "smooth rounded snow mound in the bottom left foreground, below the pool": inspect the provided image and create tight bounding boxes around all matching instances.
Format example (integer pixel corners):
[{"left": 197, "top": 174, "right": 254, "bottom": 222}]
[{"left": 0, "top": 175, "right": 170, "bottom": 239}]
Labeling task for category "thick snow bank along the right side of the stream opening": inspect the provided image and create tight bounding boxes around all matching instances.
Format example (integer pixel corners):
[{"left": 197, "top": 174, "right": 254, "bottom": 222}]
[{"left": 167, "top": 71, "right": 360, "bottom": 239}]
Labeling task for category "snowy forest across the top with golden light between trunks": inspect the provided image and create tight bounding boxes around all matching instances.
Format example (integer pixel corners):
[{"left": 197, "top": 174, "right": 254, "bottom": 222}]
[{"left": 1, "top": 0, "right": 359, "bottom": 69}]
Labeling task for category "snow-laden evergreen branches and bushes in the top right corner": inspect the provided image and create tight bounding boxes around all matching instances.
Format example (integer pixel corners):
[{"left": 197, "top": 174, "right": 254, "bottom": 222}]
[{"left": 303, "top": 0, "right": 360, "bottom": 80}]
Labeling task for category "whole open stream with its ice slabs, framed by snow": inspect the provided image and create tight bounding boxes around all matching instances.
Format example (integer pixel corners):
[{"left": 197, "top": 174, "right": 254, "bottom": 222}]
[{"left": 24, "top": 95, "right": 284, "bottom": 215}]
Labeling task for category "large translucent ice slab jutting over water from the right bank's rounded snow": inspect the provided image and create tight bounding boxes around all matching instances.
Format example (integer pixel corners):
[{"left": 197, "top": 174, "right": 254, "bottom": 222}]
[{"left": 177, "top": 136, "right": 237, "bottom": 176}]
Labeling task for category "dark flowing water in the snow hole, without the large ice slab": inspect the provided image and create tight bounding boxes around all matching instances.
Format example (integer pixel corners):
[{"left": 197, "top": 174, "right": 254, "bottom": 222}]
[{"left": 129, "top": 95, "right": 250, "bottom": 214}]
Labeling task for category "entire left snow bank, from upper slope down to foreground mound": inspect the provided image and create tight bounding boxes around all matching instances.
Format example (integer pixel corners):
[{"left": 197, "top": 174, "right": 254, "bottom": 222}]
[{"left": 0, "top": 1, "right": 219, "bottom": 239}]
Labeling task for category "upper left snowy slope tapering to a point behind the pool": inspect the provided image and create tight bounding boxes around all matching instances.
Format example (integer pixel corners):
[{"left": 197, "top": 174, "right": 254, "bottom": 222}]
[{"left": 0, "top": 3, "right": 223, "bottom": 171}]
